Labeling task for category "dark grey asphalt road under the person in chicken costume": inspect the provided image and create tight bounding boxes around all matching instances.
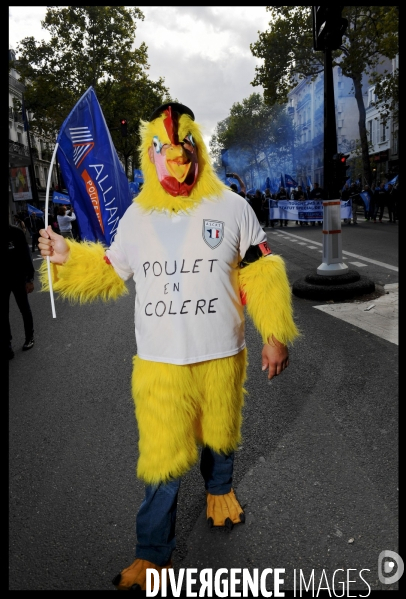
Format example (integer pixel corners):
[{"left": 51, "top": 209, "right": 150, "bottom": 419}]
[{"left": 9, "top": 222, "right": 398, "bottom": 590}]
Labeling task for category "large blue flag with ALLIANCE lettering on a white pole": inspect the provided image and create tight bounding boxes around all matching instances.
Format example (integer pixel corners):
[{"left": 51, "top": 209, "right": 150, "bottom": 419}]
[{"left": 57, "top": 87, "right": 132, "bottom": 245}]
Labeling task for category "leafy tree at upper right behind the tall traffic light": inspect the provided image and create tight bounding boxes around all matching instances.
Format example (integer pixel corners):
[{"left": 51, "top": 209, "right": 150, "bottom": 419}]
[{"left": 250, "top": 6, "right": 399, "bottom": 183}]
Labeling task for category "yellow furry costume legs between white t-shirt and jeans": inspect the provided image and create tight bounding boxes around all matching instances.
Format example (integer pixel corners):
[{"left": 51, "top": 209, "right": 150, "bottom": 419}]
[{"left": 132, "top": 350, "right": 246, "bottom": 485}]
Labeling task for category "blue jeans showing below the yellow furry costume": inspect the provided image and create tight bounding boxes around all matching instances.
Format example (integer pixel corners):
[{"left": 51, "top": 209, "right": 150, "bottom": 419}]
[{"left": 135, "top": 447, "right": 234, "bottom": 566}]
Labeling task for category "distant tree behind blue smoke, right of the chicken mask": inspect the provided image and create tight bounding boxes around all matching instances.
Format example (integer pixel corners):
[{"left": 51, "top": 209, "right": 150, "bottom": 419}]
[{"left": 210, "top": 93, "right": 295, "bottom": 190}]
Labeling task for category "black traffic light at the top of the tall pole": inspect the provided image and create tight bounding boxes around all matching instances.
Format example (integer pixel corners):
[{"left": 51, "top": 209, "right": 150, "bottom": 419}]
[{"left": 312, "top": 6, "right": 348, "bottom": 50}]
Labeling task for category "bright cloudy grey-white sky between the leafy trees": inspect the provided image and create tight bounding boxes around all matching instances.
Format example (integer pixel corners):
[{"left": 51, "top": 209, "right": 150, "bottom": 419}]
[{"left": 9, "top": 6, "right": 269, "bottom": 143}]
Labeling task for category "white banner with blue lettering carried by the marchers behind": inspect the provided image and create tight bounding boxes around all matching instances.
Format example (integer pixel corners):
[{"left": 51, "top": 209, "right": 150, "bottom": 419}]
[{"left": 269, "top": 200, "right": 351, "bottom": 222}]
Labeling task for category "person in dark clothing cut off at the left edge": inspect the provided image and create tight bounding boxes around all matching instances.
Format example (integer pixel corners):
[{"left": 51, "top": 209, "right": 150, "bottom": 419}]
[{"left": 7, "top": 225, "right": 35, "bottom": 360}]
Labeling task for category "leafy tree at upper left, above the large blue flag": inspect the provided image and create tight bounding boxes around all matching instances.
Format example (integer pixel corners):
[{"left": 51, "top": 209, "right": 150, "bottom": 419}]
[{"left": 14, "top": 6, "right": 168, "bottom": 172}]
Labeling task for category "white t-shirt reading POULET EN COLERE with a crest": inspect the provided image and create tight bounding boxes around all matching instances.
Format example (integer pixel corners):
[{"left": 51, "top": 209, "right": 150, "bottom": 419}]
[{"left": 106, "top": 190, "right": 266, "bottom": 364}]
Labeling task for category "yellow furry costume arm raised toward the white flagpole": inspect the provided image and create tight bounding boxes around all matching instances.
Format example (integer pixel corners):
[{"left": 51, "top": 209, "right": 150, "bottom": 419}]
[{"left": 39, "top": 239, "right": 128, "bottom": 304}]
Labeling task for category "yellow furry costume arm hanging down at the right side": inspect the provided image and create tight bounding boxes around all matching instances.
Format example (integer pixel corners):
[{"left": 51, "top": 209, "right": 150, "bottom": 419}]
[{"left": 240, "top": 255, "right": 299, "bottom": 345}]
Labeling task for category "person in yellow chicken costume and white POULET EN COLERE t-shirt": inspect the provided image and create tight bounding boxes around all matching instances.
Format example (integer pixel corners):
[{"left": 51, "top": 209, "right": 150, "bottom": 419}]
[{"left": 39, "top": 102, "right": 298, "bottom": 590}]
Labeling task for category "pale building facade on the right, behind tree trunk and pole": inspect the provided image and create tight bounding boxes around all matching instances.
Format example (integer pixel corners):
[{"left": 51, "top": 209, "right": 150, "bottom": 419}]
[{"left": 287, "top": 56, "right": 399, "bottom": 187}]
